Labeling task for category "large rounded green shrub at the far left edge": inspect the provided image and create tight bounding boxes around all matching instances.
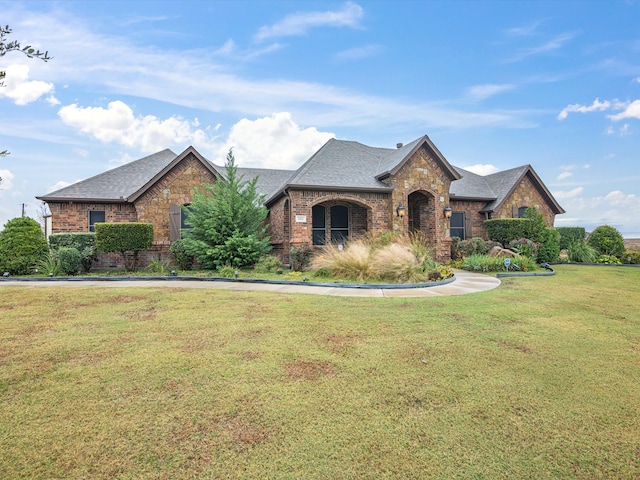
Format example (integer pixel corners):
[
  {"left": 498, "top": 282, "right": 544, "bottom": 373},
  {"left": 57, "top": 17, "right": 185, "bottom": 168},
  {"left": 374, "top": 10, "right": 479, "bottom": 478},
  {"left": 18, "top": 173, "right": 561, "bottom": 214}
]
[{"left": 0, "top": 217, "right": 49, "bottom": 275}]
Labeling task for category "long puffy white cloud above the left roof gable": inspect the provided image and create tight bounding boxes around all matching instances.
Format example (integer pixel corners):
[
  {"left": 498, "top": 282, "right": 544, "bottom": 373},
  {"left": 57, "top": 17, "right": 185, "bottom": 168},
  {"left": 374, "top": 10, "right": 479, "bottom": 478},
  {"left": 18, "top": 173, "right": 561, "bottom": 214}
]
[{"left": 58, "top": 100, "right": 222, "bottom": 152}]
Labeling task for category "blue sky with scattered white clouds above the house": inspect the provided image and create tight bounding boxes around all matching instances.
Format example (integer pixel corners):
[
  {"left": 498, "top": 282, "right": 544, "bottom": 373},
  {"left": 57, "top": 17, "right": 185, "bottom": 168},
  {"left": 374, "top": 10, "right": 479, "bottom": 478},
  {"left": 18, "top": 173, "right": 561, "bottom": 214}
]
[{"left": 0, "top": 0, "right": 640, "bottom": 237}]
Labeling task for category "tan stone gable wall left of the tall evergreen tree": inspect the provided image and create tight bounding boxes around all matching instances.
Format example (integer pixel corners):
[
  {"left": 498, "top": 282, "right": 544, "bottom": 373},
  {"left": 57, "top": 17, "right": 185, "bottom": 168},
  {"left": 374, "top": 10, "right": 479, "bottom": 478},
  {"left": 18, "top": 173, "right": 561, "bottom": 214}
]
[{"left": 135, "top": 155, "right": 216, "bottom": 242}]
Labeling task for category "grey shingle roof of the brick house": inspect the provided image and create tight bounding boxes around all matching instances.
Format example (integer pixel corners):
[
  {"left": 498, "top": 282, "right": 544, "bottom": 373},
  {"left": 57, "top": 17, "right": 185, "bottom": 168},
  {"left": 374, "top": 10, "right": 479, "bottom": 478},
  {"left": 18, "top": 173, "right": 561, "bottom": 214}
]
[{"left": 37, "top": 135, "right": 564, "bottom": 213}]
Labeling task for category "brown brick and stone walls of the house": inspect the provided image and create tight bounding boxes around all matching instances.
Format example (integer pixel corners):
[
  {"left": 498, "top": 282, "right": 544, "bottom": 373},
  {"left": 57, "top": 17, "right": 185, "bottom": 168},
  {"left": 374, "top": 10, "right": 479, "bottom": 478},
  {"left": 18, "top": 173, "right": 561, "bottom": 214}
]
[{"left": 42, "top": 143, "right": 557, "bottom": 268}]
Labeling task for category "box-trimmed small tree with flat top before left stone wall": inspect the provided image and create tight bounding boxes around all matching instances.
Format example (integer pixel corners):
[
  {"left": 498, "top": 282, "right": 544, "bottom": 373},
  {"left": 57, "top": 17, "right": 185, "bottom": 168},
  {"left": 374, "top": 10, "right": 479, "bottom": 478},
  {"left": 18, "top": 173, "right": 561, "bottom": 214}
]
[{"left": 95, "top": 223, "right": 153, "bottom": 271}]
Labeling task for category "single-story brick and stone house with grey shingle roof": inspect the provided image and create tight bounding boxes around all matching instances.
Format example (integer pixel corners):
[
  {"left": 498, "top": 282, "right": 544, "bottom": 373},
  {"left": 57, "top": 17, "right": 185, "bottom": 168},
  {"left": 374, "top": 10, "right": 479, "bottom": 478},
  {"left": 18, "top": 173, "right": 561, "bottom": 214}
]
[{"left": 38, "top": 136, "right": 564, "bottom": 266}]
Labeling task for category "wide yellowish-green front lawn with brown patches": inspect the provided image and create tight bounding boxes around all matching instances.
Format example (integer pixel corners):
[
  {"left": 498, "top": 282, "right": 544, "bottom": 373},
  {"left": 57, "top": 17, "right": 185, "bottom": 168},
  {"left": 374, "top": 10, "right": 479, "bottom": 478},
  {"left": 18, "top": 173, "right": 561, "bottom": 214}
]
[{"left": 0, "top": 266, "right": 640, "bottom": 479}]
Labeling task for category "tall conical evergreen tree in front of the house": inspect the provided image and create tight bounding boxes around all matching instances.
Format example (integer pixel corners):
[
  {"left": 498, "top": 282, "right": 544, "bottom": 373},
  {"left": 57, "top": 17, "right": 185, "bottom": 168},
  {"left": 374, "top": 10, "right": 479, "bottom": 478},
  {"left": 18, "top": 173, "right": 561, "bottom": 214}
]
[{"left": 183, "top": 150, "right": 271, "bottom": 268}]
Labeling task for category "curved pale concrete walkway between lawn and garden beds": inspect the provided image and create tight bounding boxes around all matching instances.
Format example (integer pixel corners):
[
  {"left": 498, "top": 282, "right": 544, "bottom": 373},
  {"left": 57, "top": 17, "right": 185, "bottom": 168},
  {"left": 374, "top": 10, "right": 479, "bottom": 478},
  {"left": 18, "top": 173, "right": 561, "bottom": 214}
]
[{"left": 0, "top": 270, "right": 500, "bottom": 298}]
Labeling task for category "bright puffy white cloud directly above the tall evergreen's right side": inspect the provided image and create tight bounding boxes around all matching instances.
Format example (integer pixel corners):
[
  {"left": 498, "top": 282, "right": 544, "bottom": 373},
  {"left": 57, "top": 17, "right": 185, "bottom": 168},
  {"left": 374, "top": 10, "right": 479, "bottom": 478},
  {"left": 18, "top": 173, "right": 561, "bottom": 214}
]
[{"left": 215, "top": 112, "right": 335, "bottom": 169}]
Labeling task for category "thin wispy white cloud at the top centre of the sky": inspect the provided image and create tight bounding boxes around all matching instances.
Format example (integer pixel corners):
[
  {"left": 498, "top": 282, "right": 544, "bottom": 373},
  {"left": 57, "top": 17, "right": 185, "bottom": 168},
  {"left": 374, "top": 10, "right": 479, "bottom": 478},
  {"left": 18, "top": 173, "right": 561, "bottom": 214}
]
[{"left": 254, "top": 2, "right": 364, "bottom": 42}]
